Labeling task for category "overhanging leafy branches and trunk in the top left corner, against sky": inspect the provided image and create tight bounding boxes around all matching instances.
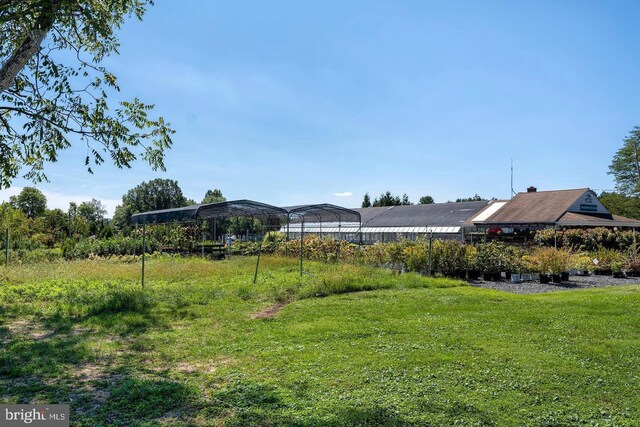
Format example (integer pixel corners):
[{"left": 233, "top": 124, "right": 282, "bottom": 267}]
[{"left": 0, "top": 0, "right": 174, "bottom": 187}]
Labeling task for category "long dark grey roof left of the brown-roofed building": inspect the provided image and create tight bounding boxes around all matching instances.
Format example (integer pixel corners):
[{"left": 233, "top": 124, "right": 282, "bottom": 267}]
[{"left": 354, "top": 200, "right": 489, "bottom": 227}]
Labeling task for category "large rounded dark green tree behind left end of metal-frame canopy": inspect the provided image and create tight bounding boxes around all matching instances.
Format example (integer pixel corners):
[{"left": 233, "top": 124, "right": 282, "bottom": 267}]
[{"left": 113, "top": 178, "right": 189, "bottom": 229}]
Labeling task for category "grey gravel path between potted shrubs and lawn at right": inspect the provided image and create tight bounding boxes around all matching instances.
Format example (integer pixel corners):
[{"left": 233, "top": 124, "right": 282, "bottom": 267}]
[{"left": 469, "top": 275, "right": 640, "bottom": 294}]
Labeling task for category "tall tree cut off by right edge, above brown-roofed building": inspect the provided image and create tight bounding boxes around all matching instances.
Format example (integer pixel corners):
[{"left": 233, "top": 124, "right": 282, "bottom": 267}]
[{"left": 608, "top": 126, "right": 640, "bottom": 196}]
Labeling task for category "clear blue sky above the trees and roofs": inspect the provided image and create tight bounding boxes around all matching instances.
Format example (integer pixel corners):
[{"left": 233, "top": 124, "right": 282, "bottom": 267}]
[{"left": 0, "top": 0, "right": 640, "bottom": 212}]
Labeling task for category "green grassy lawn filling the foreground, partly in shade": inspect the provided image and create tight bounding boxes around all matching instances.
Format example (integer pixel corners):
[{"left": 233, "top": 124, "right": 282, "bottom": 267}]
[{"left": 0, "top": 258, "right": 640, "bottom": 426}]
